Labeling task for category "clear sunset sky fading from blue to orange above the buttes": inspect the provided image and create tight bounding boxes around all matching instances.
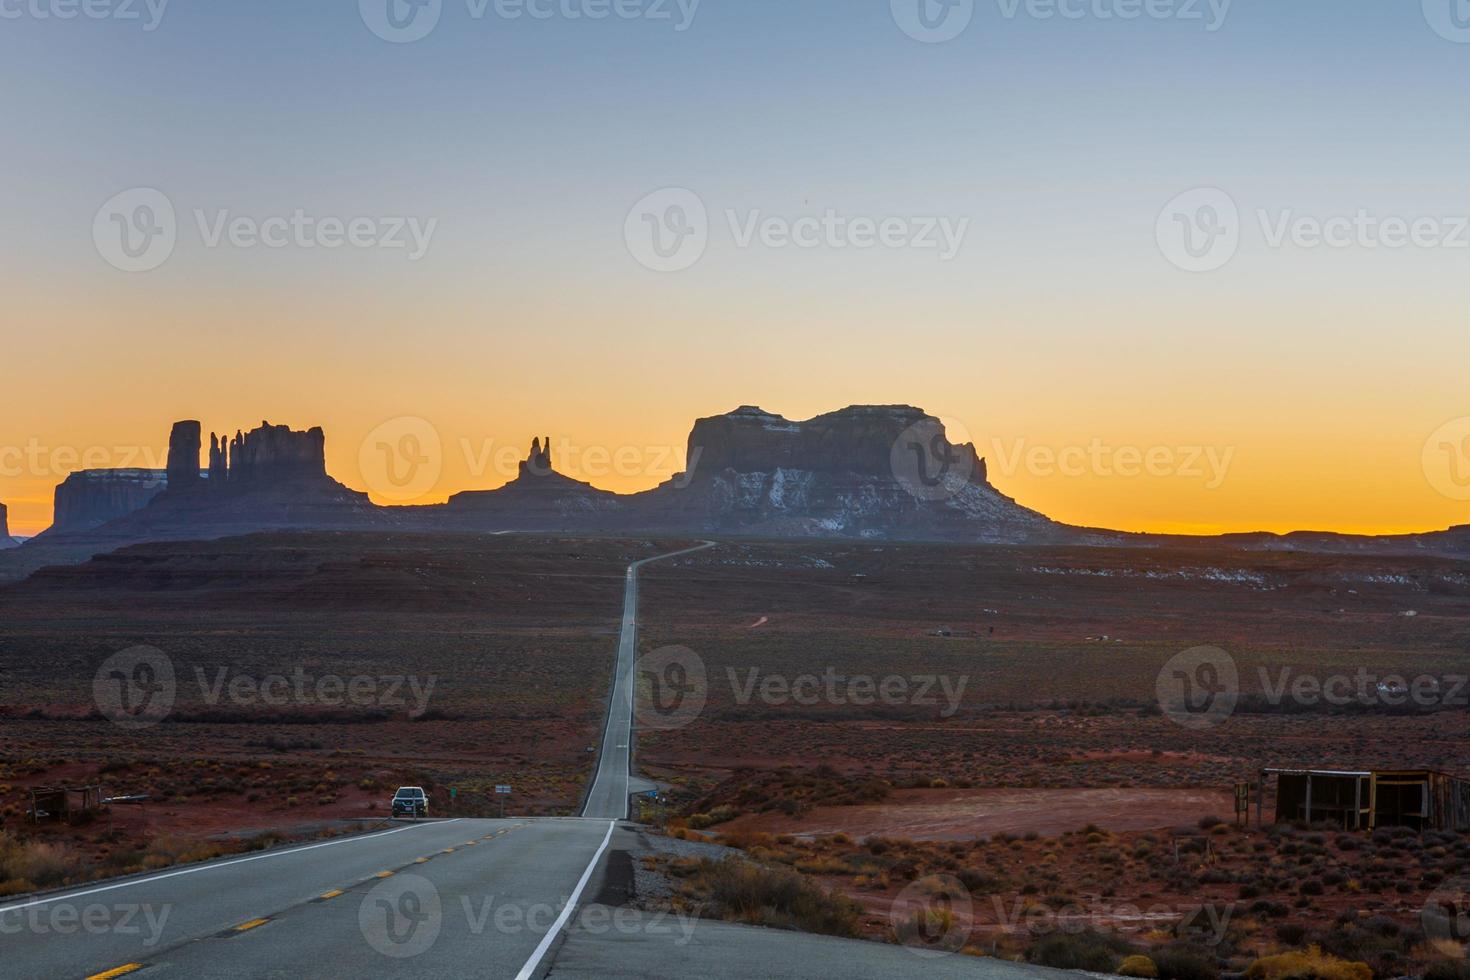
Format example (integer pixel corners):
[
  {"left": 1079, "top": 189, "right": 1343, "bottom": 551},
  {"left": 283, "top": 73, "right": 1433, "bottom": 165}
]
[{"left": 0, "top": 0, "right": 1470, "bottom": 535}]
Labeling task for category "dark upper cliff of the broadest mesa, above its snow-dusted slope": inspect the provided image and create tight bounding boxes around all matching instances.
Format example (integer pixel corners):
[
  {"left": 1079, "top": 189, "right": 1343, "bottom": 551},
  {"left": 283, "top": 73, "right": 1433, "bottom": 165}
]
[{"left": 688, "top": 406, "right": 986, "bottom": 483}]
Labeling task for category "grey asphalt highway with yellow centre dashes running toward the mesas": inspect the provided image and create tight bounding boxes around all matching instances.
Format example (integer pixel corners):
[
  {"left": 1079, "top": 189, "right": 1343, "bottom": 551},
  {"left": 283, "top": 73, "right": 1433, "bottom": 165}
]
[{"left": 0, "top": 545, "right": 1053, "bottom": 980}]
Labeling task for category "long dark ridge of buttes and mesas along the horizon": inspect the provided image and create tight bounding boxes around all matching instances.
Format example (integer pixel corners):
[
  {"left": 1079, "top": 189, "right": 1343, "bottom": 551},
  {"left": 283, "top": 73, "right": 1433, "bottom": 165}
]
[{"left": 0, "top": 406, "right": 1470, "bottom": 577}]
